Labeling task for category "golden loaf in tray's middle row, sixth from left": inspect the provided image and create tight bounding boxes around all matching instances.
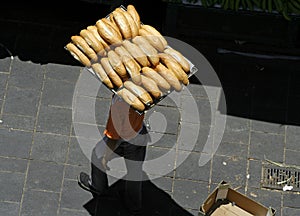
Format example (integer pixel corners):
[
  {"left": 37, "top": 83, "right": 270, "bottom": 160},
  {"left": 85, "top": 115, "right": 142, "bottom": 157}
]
[{"left": 132, "top": 35, "right": 159, "bottom": 66}]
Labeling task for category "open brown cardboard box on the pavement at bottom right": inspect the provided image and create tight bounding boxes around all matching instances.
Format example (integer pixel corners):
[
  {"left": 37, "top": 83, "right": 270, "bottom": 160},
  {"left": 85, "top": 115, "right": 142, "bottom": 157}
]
[{"left": 200, "top": 181, "right": 275, "bottom": 216}]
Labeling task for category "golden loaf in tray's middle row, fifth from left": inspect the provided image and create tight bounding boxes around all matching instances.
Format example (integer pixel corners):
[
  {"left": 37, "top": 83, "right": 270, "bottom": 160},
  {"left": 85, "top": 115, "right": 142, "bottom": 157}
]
[{"left": 123, "top": 40, "right": 150, "bottom": 67}]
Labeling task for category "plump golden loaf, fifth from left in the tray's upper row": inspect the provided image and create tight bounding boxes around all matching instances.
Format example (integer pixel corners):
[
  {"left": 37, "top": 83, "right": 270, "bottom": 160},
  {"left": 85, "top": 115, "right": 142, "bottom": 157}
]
[{"left": 96, "top": 18, "right": 122, "bottom": 45}]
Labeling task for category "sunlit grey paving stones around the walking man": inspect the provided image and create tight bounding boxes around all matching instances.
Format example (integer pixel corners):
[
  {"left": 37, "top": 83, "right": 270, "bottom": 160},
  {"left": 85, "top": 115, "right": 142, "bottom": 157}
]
[{"left": 0, "top": 54, "right": 300, "bottom": 216}]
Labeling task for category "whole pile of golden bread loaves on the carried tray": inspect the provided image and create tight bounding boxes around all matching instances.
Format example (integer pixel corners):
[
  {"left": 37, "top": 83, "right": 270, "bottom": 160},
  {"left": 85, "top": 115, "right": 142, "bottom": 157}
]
[{"left": 65, "top": 5, "right": 190, "bottom": 111}]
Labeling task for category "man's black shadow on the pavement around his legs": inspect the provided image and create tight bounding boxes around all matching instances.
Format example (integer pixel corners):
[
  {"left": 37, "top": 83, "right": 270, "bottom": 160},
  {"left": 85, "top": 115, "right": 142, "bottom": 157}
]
[{"left": 83, "top": 176, "right": 192, "bottom": 216}]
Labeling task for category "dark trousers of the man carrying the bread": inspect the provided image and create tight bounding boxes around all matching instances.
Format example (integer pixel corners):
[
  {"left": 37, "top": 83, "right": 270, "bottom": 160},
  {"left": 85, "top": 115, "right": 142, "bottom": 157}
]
[{"left": 91, "top": 127, "right": 149, "bottom": 212}]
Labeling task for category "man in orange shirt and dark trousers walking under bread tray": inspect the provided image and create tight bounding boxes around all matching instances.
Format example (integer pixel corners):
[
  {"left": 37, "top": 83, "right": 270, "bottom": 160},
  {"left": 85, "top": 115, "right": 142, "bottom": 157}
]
[{"left": 78, "top": 94, "right": 150, "bottom": 215}]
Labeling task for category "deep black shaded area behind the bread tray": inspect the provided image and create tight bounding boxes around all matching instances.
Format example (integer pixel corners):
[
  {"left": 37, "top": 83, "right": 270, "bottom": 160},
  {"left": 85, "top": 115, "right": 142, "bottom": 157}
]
[{"left": 0, "top": 0, "right": 300, "bottom": 125}]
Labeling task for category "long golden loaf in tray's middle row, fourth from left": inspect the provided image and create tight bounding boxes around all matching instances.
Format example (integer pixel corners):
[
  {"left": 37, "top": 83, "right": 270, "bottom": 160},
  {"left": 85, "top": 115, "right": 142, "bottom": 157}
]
[{"left": 115, "top": 46, "right": 142, "bottom": 85}]
